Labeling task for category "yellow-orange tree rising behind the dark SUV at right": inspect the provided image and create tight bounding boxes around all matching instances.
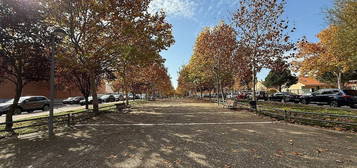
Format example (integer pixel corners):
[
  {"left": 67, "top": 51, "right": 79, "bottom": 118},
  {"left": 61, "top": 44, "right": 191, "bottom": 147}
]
[{"left": 294, "top": 25, "right": 353, "bottom": 88}]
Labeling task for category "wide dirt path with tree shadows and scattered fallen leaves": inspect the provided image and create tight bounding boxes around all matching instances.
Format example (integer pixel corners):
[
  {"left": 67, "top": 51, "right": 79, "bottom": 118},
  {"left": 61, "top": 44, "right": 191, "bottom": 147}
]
[{"left": 0, "top": 100, "right": 357, "bottom": 168}]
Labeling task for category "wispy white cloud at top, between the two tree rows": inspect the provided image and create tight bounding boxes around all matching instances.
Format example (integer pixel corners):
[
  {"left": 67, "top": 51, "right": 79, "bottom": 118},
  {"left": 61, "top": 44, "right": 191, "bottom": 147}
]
[{"left": 149, "top": 0, "right": 197, "bottom": 18}]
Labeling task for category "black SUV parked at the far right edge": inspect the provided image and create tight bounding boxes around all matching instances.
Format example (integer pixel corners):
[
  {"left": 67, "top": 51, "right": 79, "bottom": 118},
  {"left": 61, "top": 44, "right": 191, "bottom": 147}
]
[{"left": 301, "top": 89, "right": 357, "bottom": 107}]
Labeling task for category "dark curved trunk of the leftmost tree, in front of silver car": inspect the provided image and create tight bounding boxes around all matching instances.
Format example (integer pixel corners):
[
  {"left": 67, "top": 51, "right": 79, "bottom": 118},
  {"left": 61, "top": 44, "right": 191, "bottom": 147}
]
[{"left": 5, "top": 80, "right": 23, "bottom": 133}]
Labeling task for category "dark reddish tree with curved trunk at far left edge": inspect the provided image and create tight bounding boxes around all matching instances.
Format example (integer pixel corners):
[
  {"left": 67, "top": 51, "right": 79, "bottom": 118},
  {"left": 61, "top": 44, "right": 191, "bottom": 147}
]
[{"left": 0, "top": 0, "right": 50, "bottom": 132}]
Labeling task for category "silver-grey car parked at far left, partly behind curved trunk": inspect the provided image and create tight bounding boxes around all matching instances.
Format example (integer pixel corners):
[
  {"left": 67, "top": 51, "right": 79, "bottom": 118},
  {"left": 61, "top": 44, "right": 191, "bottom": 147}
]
[{"left": 0, "top": 96, "right": 50, "bottom": 115}]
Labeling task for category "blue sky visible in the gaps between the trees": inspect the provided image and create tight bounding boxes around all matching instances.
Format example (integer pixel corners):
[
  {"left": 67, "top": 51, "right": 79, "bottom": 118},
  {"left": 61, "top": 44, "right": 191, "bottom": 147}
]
[{"left": 149, "top": 0, "right": 333, "bottom": 87}]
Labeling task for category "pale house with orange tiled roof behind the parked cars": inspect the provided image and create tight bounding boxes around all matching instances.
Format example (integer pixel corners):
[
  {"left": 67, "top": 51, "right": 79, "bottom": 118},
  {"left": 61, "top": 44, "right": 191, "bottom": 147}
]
[{"left": 286, "top": 77, "right": 331, "bottom": 94}]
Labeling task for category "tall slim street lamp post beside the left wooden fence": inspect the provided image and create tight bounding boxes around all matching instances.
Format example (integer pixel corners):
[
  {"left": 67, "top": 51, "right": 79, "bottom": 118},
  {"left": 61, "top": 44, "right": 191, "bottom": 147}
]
[{"left": 48, "top": 28, "right": 66, "bottom": 137}]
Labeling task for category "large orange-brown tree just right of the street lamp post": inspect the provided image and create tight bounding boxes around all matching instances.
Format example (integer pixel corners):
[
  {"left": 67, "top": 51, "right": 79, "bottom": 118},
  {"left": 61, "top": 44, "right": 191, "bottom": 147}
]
[{"left": 47, "top": 0, "right": 173, "bottom": 111}]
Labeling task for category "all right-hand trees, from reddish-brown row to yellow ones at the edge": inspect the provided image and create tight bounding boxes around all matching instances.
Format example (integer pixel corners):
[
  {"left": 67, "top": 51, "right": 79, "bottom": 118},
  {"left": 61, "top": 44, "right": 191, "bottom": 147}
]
[{"left": 178, "top": 0, "right": 357, "bottom": 97}]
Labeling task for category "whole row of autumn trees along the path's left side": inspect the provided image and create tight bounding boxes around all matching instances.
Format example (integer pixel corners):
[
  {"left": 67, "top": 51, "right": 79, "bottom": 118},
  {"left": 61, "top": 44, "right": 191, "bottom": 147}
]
[{"left": 0, "top": 0, "right": 174, "bottom": 131}]
